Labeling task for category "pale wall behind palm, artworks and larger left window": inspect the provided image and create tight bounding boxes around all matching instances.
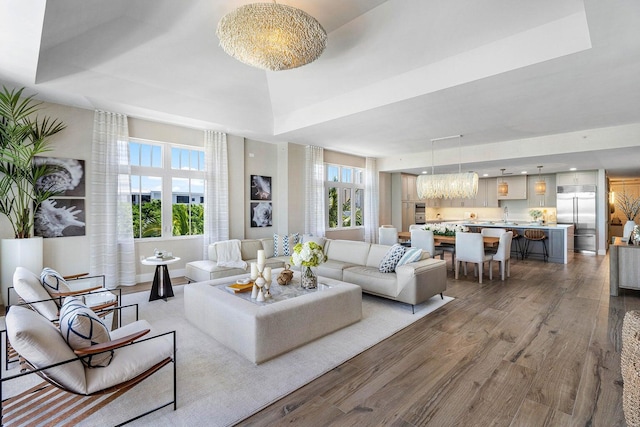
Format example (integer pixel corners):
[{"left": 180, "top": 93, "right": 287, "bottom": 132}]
[{"left": 0, "top": 103, "right": 304, "bottom": 281}]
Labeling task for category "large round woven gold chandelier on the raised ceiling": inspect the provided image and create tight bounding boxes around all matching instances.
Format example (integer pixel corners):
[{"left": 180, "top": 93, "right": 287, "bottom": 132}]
[{"left": 216, "top": 0, "right": 327, "bottom": 71}]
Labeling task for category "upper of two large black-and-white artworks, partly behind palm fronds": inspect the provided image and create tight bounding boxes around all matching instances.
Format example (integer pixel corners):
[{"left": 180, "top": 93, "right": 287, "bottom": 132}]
[{"left": 33, "top": 157, "right": 85, "bottom": 197}]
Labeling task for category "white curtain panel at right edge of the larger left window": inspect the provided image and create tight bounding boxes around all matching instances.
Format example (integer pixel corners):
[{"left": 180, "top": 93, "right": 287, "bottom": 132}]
[{"left": 203, "top": 130, "right": 229, "bottom": 259}]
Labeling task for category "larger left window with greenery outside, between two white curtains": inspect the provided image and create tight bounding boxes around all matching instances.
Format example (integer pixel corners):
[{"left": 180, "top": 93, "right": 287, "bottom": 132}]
[{"left": 129, "top": 140, "right": 204, "bottom": 238}]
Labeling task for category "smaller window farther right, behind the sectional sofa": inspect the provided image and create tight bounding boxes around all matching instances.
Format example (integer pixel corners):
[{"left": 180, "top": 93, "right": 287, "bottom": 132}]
[{"left": 325, "top": 163, "right": 364, "bottom": 229}]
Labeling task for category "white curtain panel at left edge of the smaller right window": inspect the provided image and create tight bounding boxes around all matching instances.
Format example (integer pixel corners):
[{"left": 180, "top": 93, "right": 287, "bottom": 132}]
[{"left": 304, "top": 145, "right": 325, "bottom": 237}]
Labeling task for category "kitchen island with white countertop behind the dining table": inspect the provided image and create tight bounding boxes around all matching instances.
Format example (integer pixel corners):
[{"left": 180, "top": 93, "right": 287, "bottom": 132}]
[{"left": 463, "top": 221, "right": 573, "bottom": 264}]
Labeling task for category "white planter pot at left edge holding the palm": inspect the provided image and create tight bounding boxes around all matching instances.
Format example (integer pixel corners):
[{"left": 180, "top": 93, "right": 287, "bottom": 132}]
[{"left": 0, "top": 237, "right": 44, "bottom": 305}]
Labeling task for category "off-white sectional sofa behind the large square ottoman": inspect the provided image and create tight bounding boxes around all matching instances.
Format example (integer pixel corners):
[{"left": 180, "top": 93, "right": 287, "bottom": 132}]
[{"left": 185, "top": 238, "right": 447, "bottom": 306}]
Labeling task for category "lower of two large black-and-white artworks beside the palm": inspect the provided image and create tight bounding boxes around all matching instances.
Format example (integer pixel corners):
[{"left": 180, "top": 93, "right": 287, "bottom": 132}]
[{"left": 33, "top": 199, "right": 85, "bottom": 238}]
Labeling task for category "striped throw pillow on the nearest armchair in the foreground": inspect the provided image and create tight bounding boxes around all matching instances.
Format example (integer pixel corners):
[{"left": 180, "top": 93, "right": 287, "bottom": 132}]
[{"left": 60, "top": 297, "right": 113, "bottom": 368}]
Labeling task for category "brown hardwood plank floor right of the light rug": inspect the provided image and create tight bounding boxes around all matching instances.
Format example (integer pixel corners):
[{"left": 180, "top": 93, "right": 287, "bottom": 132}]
[{"left": 241, "top": 254, "right": 640, "bottom": 426}]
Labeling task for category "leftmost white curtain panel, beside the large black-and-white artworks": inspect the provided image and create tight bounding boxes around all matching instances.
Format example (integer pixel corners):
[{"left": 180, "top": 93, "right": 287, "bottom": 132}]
[{"left": 88, "top": 111, "right": 136, "bottom": 289}]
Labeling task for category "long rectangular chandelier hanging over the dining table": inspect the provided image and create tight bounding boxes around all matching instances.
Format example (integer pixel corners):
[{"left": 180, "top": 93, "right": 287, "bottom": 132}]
[{"left": 416, "top": 135, "right": 478, "bottom": 199}]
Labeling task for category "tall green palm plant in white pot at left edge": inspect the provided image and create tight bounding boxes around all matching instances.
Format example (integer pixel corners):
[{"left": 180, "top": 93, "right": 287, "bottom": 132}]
[{"left": 0, "top": 86, "right": 65, "bottom": 304}]
